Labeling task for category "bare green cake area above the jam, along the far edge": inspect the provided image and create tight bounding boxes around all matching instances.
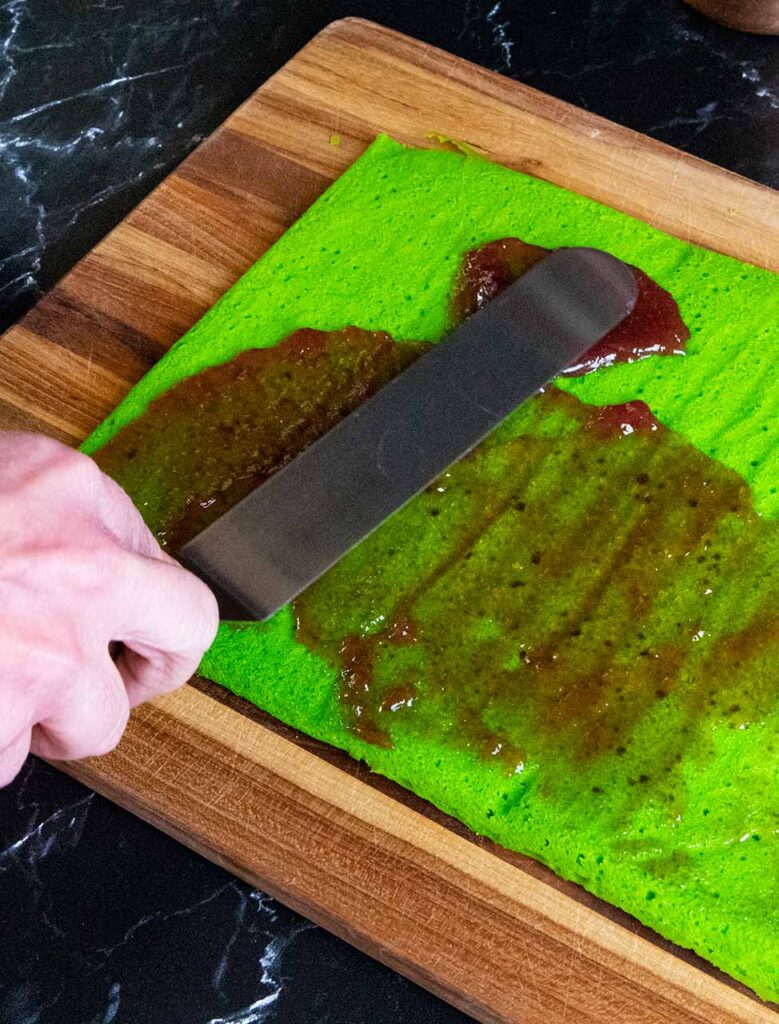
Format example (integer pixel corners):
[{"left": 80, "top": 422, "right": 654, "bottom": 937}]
[{"left": 85, "top": 137, "right": 779, "bottom": 516}]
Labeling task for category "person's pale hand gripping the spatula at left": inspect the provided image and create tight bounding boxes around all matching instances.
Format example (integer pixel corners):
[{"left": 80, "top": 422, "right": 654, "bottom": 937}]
[{"left": 0, "top": 432, "right": 218, "bottom": 785}]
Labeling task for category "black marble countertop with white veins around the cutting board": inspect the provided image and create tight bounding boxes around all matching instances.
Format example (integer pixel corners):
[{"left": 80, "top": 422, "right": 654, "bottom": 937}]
[{"left": 0, "top": 0, "right": 779, "bottom": 1024}]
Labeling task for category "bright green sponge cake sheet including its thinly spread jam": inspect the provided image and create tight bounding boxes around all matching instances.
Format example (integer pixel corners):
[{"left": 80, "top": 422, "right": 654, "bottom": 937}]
[{"left": 85, "top": 138, "right": 779, "bottom": 998}]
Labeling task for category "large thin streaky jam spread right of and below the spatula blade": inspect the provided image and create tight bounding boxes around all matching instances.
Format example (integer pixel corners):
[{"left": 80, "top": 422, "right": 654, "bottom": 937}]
[{"left": 295, "top": 391, "right": 779, "bottom": 784}]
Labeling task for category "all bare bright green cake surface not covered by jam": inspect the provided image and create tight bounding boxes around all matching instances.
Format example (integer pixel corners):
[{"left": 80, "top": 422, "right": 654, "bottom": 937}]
[{"left": 84, "top": 137, "right": 779, "bottom": 999}]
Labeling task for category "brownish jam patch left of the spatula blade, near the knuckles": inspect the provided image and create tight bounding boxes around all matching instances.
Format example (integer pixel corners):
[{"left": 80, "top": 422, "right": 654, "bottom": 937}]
[{"left": 96, "top": 328, "right": 428, "bottom": 551}]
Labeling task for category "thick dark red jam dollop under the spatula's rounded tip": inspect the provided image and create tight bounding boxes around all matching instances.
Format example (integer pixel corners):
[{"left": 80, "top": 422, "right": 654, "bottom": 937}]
[{"left": 452, "top": 238, "right": 690, "bottom": 377}]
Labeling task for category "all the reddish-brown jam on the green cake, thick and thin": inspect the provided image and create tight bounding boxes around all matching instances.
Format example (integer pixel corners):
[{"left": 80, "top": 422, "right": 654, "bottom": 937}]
[{"left": 97, "top": 239, "right": 779, "bottom": 801}]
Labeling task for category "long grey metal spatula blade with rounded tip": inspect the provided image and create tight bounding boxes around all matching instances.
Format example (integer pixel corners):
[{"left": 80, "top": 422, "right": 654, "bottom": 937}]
[{"left": 180, "top": 249, "right": 637, "bottom": 618}]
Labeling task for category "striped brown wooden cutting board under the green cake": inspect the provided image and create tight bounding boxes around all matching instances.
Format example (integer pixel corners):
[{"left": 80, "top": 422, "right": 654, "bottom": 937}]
[{"left": 0, "top": 19, "right": 779, "bottom": 1024}]
